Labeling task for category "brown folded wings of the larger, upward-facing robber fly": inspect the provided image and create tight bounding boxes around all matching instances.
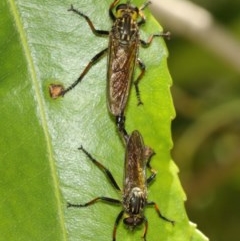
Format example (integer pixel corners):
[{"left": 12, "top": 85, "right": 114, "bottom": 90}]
[{"left": 107, "top": 35, "right": 138, "bottom": 116}]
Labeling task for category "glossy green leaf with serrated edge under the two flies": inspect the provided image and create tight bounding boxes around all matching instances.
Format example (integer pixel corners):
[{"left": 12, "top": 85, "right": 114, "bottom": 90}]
[{"left": 0, "top": 0, "right": 207, "bottom": 241}]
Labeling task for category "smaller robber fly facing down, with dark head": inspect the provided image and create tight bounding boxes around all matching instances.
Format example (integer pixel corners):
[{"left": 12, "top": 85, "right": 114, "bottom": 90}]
[{"left": 68, "top": 130, "right": 174, "bottom": 241}]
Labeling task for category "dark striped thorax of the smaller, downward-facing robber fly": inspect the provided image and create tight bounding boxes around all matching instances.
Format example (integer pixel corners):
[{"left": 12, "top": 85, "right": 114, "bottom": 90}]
[{"left": 124, "top": 187, "right": 146, "bottom": 215}]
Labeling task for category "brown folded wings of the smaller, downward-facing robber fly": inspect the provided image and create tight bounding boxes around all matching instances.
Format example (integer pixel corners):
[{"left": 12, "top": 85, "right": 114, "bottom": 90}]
[{"left": 124, "top": 131, "right": 146, "bottom": 193}]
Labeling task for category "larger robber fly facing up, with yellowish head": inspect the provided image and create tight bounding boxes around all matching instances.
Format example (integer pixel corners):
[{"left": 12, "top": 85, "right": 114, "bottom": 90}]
[{"left": 50, "top": 0, "right": 169, "bottom": 140}]
